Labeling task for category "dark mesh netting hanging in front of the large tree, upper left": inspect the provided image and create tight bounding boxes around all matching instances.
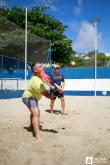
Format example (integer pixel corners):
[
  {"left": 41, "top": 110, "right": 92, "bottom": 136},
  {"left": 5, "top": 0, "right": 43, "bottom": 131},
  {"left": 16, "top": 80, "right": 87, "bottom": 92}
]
[{"left": 0, "top": 15, "right": 51, "bottom": 71}]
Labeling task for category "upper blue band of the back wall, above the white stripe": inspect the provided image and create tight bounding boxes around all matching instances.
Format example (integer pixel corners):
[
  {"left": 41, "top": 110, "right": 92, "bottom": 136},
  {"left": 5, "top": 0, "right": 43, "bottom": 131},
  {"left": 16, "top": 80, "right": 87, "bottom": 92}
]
[{"left": 0, "top": 67, "right": 110, "bottom": 79}]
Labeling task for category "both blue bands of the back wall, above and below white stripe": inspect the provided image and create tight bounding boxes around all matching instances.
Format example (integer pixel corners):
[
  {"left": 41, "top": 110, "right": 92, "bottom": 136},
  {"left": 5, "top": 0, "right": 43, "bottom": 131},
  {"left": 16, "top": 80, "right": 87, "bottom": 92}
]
[{"left": 0, "top": 67, "right": 110, "bottom": 99}]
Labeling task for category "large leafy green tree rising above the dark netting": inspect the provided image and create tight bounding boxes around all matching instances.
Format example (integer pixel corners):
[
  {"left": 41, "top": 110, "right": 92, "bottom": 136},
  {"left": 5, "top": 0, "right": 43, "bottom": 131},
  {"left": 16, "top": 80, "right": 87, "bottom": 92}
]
[{"left": 0, "top": 6, "right": 72, "bottom": 65}]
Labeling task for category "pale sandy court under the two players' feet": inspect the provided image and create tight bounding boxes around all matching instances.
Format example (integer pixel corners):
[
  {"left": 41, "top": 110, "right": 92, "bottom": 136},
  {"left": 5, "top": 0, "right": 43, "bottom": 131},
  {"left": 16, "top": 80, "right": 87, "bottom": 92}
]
[{"left": 0, "top": 96, "right": 110, "bottom": 165}]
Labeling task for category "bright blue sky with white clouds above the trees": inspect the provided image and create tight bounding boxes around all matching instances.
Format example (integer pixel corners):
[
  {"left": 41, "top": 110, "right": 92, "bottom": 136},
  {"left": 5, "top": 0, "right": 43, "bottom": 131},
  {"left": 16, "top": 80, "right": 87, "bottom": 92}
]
[{"left": 0, "top": 0, "right": 110, "bottom": 55}]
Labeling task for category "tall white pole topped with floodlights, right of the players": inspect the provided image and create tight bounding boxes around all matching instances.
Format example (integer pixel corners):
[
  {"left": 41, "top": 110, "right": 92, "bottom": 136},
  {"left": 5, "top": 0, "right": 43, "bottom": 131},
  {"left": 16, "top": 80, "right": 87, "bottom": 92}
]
[{"left": 91, "top": 17, "right": 100, "bottom": 96}]
